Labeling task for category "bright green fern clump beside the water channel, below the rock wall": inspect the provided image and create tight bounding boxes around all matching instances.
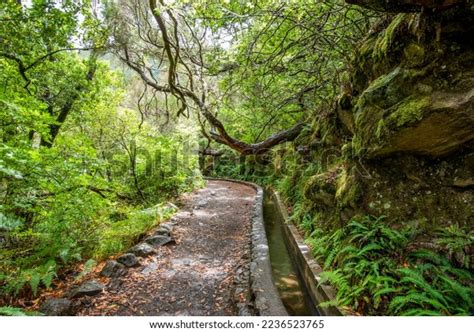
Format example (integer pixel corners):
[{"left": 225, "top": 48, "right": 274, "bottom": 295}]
[{"left": 308, "top": 217, "right": 474, "bottom": 315}]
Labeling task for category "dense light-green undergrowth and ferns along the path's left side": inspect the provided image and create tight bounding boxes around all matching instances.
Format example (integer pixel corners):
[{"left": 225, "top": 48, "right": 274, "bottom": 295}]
[{"left": 0, "top": 99, "right": 202, "bottom": 301}]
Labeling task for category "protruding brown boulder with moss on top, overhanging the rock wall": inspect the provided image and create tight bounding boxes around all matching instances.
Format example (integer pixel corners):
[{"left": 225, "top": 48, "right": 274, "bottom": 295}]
[{"left": 354, "top": 89, "right": 474, "bottom": 158}]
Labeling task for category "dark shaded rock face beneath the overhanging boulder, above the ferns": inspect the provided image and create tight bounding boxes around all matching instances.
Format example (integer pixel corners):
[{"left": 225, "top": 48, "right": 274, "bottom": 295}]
[{"left": 358, "top": 153, "right": 474, "bottom": 231}]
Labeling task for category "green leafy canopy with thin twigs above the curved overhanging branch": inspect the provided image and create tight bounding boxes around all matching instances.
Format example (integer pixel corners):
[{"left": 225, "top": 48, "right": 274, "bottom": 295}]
[{"left": 189, "top": 0, "right": 370, "bottom": 150}]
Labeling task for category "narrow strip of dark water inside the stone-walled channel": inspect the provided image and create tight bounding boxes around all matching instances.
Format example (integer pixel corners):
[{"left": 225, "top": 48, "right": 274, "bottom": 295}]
[{"left": 263, "top": 193, "right": 318, "bottom": 316}]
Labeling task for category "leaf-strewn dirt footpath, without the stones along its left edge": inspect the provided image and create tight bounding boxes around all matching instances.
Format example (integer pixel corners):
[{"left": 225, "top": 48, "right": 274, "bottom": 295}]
[{"left": 77, "top": 180, "right": 255, "bottom": 316}]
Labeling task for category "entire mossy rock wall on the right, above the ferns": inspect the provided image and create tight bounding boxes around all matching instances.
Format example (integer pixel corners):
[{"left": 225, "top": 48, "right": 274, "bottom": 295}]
[{"left": 270, "top": 3, "right": 474, "bottom": 241}]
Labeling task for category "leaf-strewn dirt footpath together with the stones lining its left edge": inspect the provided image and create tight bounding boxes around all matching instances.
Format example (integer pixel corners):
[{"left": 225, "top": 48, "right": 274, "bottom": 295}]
[{"left": 41, "top": 181, "right": 262, "bottom": 316}]
